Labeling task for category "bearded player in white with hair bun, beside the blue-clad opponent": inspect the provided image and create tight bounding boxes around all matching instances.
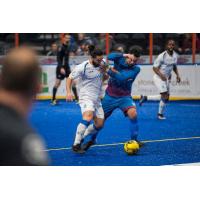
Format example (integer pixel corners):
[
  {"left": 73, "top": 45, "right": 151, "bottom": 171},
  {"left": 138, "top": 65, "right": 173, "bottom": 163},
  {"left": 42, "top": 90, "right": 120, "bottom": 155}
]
[{"left": 66, "top": 46, "right": 108, "bottom": 153}]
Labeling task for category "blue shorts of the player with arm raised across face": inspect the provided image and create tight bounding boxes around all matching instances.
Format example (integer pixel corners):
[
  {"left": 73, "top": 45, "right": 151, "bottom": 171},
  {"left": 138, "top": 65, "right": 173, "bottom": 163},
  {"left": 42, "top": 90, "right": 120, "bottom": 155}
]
[{"left": 102, "top": 94, "right": 136, "bottom": 118}]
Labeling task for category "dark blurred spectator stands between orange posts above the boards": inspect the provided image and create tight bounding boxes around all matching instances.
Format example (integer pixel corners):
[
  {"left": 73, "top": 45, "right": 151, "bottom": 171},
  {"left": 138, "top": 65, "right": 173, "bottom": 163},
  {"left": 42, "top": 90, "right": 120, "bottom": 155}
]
[{"left": 0, "top": 33, "right": 200, "bottom": 56}]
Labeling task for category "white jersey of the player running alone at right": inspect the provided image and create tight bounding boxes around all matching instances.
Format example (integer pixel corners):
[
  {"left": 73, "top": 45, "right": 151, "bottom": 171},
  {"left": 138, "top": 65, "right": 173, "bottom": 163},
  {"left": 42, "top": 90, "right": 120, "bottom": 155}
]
[{"left": 153, "top": 51, "right": 178, "bottom": 78}]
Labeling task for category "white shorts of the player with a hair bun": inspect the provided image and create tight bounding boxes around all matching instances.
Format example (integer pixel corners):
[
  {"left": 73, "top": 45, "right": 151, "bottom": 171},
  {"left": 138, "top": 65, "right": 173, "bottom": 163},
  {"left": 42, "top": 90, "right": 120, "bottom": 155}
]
[{"left": 79, "top": 100, "right": 104, "bottom": 119}]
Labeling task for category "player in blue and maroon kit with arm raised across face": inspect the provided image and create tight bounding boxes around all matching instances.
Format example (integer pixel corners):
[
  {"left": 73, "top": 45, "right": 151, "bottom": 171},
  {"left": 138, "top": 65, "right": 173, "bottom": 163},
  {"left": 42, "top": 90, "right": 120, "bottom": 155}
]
[{"left": 82, "top": 49, "right": 142, "bottom": 151}]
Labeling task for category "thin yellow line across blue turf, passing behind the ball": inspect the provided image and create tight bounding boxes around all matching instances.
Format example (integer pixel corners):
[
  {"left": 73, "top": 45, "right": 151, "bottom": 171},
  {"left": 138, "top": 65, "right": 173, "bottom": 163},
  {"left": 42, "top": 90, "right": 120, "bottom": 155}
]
[{"left": 44, "top": 136, "right": 200, "bottom": 151}]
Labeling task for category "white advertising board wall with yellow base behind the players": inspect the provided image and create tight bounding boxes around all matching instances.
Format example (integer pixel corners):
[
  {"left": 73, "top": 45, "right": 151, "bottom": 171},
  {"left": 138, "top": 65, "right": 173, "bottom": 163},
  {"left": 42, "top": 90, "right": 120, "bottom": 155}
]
[{"left": 38, "top": 65, "right": 200, "bottom": 100}]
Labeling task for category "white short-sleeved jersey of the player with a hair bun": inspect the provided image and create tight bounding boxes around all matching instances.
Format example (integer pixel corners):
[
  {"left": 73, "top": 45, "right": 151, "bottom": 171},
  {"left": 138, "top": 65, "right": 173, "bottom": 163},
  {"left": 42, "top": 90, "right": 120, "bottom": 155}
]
[{"left": 69, "top": 60, "right": 103, "bottom": 102}]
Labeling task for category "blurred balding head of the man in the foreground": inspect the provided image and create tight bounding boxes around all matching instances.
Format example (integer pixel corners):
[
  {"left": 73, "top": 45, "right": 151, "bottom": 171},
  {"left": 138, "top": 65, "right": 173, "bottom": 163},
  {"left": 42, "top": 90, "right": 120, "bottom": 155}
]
[{"left": 0, "top": 47, "right": 41, "bottom": 96}]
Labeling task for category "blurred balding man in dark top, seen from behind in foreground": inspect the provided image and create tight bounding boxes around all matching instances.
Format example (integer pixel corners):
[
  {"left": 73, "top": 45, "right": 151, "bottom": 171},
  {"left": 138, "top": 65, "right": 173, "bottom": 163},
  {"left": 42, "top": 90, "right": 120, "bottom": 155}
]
[{"left": 0, "top": 47, "right": 49, "bottom": 166}]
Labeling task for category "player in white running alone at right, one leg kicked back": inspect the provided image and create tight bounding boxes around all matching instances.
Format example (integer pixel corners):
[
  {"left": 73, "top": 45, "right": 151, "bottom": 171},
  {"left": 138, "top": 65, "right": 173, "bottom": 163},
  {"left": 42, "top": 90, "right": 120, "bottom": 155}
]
[{"left": 139, "top": 40, "right": 181, "bottom": 120}]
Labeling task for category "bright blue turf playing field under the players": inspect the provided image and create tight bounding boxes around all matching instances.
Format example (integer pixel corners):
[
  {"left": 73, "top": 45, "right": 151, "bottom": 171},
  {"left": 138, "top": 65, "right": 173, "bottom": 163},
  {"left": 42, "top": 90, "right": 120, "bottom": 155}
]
[{"left": 30, "top": 101, "right": 200, "bottom": 166}]
